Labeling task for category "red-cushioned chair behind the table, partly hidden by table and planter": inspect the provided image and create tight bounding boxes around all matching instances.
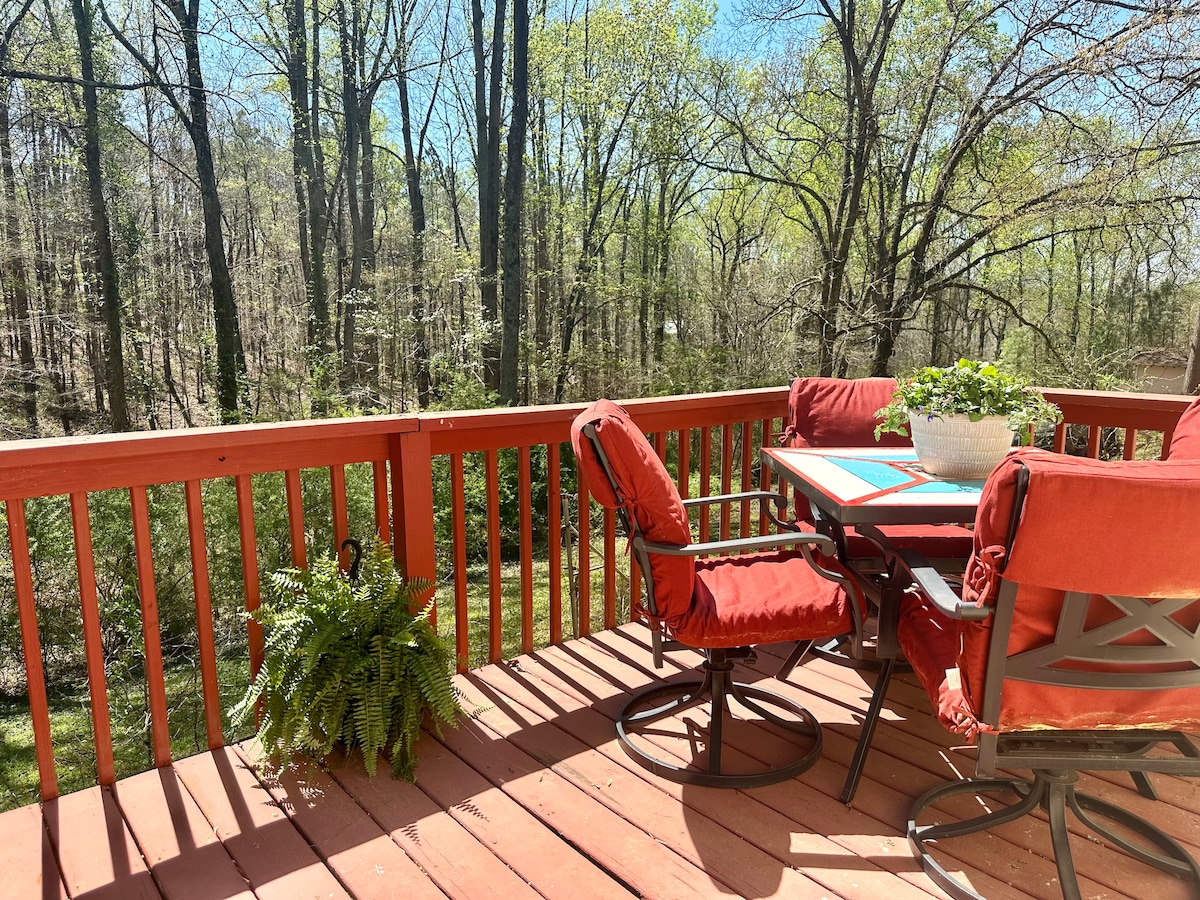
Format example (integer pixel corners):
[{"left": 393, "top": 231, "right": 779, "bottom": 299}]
[{"left": 776, "top": 378, "right": 972, "bottom": 679}]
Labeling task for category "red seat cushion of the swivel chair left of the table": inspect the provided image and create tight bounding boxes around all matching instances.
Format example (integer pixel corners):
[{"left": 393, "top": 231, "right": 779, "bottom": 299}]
[{"left": 668, "top": 552, "right": 852, "bottom": 647}]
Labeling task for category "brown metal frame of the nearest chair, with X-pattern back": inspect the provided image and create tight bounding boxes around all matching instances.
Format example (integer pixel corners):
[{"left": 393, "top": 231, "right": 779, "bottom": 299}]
[{"left": 856, "top": 469, "right": 1200, "bottom": 900}]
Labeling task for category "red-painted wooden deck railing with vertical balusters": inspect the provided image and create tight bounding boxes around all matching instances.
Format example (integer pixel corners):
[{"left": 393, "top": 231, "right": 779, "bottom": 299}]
[{"left": 0, "top": 388, "right": 1189, "bottom": 799}]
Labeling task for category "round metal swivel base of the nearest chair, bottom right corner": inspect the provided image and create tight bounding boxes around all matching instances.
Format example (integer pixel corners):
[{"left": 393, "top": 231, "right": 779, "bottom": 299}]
[{"left": 908, "top": 769, "right": 1200, "bottom": 900}]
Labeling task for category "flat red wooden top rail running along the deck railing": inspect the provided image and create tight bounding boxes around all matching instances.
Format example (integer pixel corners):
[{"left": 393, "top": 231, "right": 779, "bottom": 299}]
[{"left": 0, "top": 385, "right": 1193, "bottom": 500}]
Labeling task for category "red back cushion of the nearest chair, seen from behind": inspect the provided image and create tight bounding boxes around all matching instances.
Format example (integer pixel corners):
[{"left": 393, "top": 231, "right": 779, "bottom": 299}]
[{"left": 960, "top": 450, "right": 1200, "bottom": 731}]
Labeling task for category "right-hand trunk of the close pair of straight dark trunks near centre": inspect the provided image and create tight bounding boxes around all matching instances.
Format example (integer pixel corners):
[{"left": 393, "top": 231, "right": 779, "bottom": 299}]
[{"left": 500, "top": 0, "right": 529, "bottom": 406}]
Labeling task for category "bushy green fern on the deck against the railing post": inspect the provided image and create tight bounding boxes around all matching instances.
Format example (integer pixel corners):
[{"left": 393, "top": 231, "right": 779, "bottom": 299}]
[{"left": 232, "top": 544, "right": 461, "bottom": 781}]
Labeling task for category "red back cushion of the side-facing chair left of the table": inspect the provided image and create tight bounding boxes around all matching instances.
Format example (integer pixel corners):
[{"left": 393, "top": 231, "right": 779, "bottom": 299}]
[{"left": 571, "top": 400, "right": 696, "bottom": 628}]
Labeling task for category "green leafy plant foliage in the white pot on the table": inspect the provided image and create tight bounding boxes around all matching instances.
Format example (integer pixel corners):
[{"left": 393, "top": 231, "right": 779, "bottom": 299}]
[{"left": 875, "top": 359, "right": 1062, "bottom": 440}]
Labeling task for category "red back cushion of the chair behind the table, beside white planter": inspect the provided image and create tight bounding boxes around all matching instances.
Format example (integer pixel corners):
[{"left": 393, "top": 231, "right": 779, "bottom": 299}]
[{"left": 781, "top": 378, "right": 912, "bottom": 446}]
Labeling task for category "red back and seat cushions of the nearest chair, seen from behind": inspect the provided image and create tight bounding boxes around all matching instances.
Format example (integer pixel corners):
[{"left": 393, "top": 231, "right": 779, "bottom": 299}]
[{"left": 900, "top": 451, "right": 1200, "bottom": 731}]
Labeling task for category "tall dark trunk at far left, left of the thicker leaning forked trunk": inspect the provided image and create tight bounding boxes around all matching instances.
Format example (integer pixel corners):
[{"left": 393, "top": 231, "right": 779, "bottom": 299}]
[{"left": 71, "top": 0, "right": 130, "bottom": 431}]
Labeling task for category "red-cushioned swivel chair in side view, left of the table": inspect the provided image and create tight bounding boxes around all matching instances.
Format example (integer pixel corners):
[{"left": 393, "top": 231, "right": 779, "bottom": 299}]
[{"left": 571, "top": 400, "right": 856, "bottom": 787}]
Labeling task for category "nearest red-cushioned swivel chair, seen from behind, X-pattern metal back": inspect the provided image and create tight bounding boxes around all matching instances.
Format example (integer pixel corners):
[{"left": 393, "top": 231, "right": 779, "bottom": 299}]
[{"left": 872, "top": 451, "right": 1200, "bottom": 898}]
